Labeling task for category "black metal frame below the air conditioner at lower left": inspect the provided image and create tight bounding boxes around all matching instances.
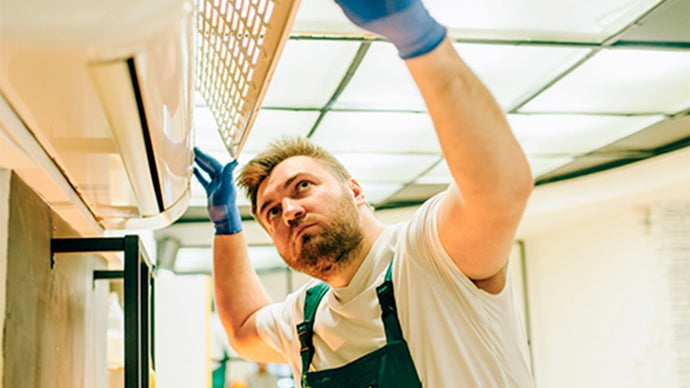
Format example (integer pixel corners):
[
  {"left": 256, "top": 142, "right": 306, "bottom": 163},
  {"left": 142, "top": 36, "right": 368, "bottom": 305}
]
[{"left": 50, "top": 235, "right": 155, "bottom": 388}]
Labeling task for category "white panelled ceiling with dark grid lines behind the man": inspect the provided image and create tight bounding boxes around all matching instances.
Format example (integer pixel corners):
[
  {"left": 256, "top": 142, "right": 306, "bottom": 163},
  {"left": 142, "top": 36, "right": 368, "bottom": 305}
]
[{"left": 182, "top": 0, "right": 690, "bottom": 218}]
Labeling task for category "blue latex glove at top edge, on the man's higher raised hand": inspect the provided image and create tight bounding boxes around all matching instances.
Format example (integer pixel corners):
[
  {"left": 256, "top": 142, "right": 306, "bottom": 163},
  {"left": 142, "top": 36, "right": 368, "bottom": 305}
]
[{"left": 335, "top": 0, "right": 446, "bottom": 59}]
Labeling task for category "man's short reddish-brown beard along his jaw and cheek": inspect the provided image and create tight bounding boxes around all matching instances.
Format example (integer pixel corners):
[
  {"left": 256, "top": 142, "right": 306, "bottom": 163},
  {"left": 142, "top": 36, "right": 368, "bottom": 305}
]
[{"left": 293, "top": 193, "right": 364, "bottom": 280}]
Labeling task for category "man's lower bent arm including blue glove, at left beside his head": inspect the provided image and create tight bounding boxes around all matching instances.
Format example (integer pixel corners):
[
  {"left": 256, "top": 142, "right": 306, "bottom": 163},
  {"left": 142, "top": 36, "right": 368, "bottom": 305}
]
[{"left": 194, "top": 148, "right": 285, "bottom": 363}]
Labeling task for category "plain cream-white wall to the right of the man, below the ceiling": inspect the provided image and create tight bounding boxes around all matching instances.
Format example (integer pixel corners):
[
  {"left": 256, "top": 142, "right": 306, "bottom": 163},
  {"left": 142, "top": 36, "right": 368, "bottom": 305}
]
[{"left": 520, "top": 147, "right": 690, "bottom": 388}]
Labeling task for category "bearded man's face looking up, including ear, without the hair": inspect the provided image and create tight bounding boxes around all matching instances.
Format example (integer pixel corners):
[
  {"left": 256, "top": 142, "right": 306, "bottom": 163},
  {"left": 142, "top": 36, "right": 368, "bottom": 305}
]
[{"left": 251, "top": 156, "right": 363, "bottom": 280}]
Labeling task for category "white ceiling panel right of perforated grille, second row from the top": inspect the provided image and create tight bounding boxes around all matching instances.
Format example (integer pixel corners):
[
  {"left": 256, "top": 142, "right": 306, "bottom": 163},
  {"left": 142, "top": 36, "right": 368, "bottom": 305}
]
[{"left": 262, "top": 40, "right": 359, "bottom": 108}]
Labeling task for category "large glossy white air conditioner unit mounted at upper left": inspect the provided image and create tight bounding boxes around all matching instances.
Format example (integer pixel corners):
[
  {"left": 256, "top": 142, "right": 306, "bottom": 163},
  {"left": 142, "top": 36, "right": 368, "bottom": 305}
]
[{"left": 0, "top": 0, "right": 195, "bottom": 229}]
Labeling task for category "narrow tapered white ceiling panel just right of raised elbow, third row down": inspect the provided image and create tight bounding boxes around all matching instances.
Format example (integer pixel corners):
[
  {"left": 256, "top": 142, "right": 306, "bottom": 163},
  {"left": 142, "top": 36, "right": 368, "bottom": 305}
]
[{"left": 508, "top": 114, "right": 664, "bottom": 155}]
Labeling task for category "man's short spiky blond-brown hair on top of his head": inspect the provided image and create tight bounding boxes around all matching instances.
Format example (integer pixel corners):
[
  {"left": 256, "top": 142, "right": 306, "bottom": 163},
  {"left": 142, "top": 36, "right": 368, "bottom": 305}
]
[{"left": 237, "top": 136, "right": 350, "bottom": 216}]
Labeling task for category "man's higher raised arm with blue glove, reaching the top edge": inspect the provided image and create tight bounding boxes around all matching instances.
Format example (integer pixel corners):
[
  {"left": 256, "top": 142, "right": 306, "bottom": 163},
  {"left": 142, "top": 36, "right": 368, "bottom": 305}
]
[{"left": 336, "top": 0, "right": 532, "bottom": 292}]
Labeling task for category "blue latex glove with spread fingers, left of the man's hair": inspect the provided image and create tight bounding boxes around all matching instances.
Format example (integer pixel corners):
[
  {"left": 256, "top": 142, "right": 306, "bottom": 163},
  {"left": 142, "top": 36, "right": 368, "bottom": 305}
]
[{"left": 194, "top": 147, "right": 242, "bottom": 234}]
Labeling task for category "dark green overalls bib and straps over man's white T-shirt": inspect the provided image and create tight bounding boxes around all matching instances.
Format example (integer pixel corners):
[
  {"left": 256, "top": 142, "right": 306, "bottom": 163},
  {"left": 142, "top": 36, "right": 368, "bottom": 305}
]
[{"left": 297, "top": 260, "right": 422, "bottom": 388}]
